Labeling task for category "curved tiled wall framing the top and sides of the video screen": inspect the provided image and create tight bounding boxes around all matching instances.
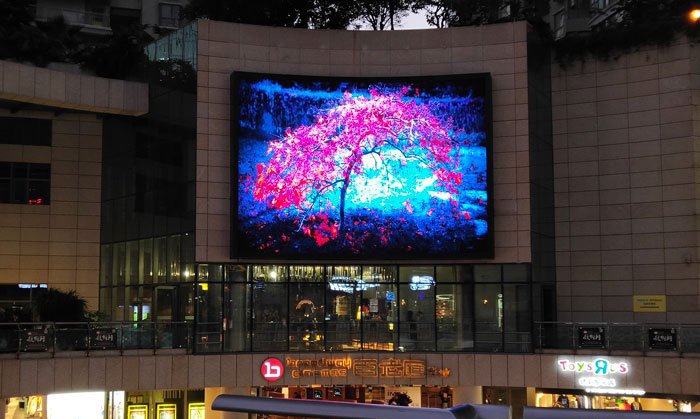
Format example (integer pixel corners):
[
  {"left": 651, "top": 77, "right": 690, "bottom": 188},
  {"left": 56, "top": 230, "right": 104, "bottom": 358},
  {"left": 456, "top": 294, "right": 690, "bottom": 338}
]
[{"left": 196, "top": 20, "right": 531, "bottom": 263}]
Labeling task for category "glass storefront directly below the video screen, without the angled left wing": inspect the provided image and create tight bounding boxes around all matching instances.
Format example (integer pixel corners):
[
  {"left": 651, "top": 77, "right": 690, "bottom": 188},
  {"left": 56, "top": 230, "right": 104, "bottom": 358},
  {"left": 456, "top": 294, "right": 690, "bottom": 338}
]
[{"left": 189, "top": 264, "right": 531, "bottom": 353}]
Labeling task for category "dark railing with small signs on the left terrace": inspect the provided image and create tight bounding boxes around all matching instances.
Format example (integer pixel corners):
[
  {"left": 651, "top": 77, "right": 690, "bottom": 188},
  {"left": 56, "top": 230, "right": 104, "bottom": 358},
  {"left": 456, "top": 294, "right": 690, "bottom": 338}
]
[{"left": 0, "top": 322, "right": 193, "bottom": 354}]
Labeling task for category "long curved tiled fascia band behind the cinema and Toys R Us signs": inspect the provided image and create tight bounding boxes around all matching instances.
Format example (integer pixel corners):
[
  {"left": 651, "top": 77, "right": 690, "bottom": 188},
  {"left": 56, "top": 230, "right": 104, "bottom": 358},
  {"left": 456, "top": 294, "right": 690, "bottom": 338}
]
[{"left": 0, "top": 352, "right": 700, "bottom": 402}]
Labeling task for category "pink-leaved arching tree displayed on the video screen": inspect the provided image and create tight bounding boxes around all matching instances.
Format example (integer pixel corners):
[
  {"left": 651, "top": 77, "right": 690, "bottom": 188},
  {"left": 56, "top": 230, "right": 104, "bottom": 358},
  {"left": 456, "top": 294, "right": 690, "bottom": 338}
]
[{"left": 252, "top": 86, "right": 468, "bottom": 246}]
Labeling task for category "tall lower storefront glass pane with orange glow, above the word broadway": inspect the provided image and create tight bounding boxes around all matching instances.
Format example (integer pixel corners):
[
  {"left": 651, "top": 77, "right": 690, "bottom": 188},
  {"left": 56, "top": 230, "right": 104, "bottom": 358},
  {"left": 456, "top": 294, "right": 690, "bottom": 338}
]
[{"left": 289, "top": 282, "right": 325, "bottom": 351}]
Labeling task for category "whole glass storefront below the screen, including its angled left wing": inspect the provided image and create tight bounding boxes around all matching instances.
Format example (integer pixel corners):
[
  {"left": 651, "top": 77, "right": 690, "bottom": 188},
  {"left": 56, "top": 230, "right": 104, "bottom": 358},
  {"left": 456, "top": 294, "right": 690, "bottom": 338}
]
[{"left": 100, "top": 240, "right": 532, "bottom": 353}]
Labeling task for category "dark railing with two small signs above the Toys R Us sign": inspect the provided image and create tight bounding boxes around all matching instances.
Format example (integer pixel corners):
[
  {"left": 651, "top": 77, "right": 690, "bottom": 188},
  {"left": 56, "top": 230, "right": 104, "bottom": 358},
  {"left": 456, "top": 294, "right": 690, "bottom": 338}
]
[{"left": 533, "top": 322, "right": 700, "bottom": 353}]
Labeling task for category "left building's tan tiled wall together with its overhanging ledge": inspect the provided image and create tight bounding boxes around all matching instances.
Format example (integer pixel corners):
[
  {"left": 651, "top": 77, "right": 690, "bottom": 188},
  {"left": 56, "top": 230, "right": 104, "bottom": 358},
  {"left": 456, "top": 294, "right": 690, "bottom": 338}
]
[{"left": 0, "top": 61, "right": 148, "bottom": 309}]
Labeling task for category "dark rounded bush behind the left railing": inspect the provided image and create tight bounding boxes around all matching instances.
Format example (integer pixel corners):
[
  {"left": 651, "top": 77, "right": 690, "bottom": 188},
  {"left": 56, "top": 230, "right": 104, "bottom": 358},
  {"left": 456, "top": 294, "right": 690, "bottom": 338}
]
[{"left": 34, "top": 288, "right": 89, "bottom": 322}]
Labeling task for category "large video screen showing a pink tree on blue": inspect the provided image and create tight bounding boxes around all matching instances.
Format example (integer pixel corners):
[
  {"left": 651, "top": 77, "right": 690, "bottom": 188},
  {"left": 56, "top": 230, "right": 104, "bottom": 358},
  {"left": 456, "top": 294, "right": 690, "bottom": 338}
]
[{"left": 231, "top": 72, "right": 493, "bottom": 260}]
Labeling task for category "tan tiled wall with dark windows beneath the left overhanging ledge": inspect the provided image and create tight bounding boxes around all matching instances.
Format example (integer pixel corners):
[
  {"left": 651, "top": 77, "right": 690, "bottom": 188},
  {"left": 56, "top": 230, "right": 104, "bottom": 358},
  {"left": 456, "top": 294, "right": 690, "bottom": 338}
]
[{"left": 0, "top": 109, "right": 102, "bottom": 309}]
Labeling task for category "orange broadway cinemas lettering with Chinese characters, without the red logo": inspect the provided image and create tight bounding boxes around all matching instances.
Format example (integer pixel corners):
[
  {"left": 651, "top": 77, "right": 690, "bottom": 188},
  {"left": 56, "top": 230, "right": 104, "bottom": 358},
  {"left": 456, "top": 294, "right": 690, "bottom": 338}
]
[{"left": 285, "top": 358, "right": 450, "bottom": 379}]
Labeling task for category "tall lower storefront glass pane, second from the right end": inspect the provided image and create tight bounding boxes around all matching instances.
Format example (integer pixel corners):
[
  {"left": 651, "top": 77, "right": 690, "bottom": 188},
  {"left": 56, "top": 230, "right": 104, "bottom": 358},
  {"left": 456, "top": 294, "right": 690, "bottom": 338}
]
[{"left": 474, "top": 284, "right": 503, "bottom": 352}]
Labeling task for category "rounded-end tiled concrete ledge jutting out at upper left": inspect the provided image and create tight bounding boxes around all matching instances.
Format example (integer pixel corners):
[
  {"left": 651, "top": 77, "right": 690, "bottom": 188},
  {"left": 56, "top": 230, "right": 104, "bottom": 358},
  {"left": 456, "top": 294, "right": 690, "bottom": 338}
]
[{"left": 0, "top": 61, "right": 148, "bottom": 116}]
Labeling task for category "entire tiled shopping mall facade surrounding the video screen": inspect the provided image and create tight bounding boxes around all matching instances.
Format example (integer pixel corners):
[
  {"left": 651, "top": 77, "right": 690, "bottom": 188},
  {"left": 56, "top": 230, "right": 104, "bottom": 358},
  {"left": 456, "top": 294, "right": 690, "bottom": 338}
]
[{"left": 0, "top": 20, "right": 700, "bottom": 418}]
